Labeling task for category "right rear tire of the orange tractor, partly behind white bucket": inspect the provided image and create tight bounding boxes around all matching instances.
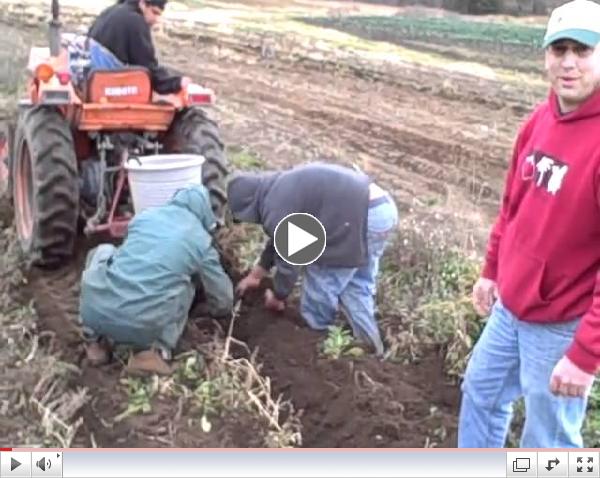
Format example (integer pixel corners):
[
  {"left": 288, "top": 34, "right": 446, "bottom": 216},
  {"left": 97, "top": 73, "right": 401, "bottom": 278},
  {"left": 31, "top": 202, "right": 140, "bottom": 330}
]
[{"left": 164, "top": 108, "right": 229, "bottom": 225}]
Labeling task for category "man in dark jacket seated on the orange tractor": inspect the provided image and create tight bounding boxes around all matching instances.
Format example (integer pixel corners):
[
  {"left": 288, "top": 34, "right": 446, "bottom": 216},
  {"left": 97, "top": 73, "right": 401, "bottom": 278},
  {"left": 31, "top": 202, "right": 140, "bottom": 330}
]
[{"left": 88, "top": 0, "right": 191, "bottom": 94}]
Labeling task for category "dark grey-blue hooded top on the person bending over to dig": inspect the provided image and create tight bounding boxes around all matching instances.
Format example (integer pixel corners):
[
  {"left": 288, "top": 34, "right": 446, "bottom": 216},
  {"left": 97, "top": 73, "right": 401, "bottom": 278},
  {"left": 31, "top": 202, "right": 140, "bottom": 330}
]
[{"left": 228, "top": 163, "right": 370, "bottom": 299}]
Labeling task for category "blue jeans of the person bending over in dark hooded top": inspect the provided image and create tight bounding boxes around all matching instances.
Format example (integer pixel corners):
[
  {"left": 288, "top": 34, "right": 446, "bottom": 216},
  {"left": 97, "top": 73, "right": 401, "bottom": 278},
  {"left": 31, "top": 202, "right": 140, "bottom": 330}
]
[{"left": 300, "top": 197, "right": 398, "bottom": 355}]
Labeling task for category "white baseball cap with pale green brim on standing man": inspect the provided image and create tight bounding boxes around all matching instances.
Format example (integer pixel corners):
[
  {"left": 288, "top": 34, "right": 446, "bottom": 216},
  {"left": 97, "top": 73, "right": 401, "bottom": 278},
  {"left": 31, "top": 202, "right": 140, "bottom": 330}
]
[{"left": 543, "top": 0, "right": 600, "bottom": 48}]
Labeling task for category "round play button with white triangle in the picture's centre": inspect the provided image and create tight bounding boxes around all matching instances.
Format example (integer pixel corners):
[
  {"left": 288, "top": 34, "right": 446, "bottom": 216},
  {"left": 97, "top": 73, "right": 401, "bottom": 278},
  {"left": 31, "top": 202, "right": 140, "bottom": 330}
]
[{"left": 274, "top": 212, "right": 327, "bottom": 266}]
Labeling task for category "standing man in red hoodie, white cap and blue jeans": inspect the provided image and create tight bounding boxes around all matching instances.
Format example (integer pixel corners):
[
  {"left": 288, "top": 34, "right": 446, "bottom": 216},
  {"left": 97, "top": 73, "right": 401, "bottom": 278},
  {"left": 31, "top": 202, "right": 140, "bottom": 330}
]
[{"left": 458, "top": 0, "right": 600, "bottom": 448}]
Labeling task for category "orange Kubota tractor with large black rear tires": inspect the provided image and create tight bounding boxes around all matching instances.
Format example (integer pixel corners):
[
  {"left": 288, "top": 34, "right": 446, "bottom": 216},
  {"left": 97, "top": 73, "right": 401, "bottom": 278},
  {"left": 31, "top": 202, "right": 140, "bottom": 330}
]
[{"left": 0, "top": 0, "right": 228, "bottom": 266}]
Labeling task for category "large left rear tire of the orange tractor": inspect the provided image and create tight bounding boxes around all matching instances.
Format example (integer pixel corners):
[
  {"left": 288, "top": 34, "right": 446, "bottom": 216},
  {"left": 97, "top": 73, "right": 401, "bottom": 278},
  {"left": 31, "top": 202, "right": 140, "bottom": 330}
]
[{"left": 12, "top": 106, "right": 79, "bottom": 267}]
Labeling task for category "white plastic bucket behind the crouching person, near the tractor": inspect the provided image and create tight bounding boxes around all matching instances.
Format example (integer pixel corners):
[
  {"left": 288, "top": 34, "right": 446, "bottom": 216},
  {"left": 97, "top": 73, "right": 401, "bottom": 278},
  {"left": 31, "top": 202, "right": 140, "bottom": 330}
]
[{"left": 125, "top": 154, "right": 204, "bottom": 213}]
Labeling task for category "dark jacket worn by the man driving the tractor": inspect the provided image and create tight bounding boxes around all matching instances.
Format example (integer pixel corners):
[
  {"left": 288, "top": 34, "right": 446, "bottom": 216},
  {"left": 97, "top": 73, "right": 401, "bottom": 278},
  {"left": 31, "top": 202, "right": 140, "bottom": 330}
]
[{"left": 88, "top": 0, "right": 181, "bottom": 94}]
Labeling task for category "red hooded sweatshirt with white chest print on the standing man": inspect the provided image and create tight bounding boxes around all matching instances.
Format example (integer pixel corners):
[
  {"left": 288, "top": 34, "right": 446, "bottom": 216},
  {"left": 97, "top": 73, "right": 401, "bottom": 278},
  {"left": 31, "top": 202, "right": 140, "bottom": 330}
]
[{"left": 482, "top": 91, "right": 600, "bottom": 373}]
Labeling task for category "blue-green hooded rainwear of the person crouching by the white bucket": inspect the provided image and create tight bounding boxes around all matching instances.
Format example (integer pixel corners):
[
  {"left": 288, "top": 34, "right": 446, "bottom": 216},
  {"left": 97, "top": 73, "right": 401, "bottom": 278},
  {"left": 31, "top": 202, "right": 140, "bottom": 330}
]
[{"left": 80, "top": 186, "right": 233, "bottom": 348}]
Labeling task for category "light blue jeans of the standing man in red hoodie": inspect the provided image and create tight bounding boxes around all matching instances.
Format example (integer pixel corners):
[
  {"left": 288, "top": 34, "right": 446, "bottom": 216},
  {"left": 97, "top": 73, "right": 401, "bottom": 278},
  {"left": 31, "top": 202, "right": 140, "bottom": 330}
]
[{"left": 458, "top": 301, "right": 587, "bottom": 448}]
